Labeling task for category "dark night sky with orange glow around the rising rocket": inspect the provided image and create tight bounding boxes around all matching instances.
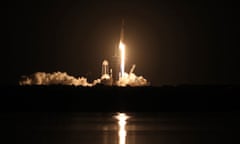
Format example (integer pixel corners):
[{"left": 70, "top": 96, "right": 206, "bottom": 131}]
[{"left": 4, "top": 0, "right": 240, "bottom": 85}]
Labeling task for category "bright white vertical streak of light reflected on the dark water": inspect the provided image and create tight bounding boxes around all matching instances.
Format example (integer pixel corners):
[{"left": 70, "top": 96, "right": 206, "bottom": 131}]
[{"left": 115, "top": 113, "right": 129, "bottom": 144}]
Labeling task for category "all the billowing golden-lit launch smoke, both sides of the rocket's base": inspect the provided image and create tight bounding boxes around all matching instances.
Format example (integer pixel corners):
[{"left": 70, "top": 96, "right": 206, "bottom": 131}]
[{"left": 19, "top": 72, "right": 148, "bottom": 87}]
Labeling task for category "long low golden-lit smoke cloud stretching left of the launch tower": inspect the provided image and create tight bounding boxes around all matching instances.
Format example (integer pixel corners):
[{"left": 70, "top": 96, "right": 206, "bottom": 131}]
[{"left": 19, "top": 72, "right": 101, "bottom": 86}]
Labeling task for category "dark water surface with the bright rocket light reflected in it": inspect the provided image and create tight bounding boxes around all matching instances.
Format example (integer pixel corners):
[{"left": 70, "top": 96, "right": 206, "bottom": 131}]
[{"left": 7, "top": 113, "right": 239, "bottom": 144}]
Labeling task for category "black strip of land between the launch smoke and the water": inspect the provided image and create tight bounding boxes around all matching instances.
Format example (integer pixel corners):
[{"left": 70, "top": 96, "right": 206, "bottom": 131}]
[{"left": 1, "top": 85, "right": 240, "bottom": 112}]
